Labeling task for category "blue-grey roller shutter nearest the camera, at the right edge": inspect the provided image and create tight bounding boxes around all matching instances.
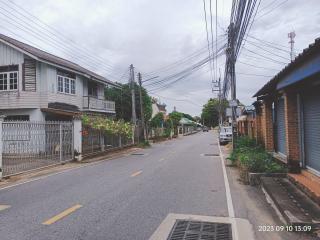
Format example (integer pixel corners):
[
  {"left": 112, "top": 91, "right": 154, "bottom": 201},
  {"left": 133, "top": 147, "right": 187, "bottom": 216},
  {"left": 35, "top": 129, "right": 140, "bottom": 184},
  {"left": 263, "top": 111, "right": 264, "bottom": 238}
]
[{"left": 303, "top": 89, "right": 320, "bottom": 173}]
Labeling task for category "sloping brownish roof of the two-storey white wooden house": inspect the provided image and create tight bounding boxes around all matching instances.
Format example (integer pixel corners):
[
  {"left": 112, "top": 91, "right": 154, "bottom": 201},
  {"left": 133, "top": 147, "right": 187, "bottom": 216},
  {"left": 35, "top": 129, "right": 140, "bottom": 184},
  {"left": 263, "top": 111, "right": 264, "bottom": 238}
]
[{"left": 0, "top": 34, "right": 118, "bottom": 86}]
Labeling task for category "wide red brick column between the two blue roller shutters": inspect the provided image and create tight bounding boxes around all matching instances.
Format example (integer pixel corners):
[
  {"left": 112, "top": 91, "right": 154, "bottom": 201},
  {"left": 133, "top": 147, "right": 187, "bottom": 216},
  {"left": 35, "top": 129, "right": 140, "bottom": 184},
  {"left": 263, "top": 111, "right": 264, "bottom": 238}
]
[{"left": 284, "top": 92, "right": 301, "bottom": 173}]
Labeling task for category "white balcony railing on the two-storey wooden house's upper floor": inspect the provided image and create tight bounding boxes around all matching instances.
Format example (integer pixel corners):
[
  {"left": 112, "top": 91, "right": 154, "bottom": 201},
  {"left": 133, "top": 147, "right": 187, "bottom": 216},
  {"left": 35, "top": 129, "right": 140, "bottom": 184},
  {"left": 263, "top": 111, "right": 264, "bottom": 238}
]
[{"left": 83, "top": 96, "right": 115, "bottom": 113}]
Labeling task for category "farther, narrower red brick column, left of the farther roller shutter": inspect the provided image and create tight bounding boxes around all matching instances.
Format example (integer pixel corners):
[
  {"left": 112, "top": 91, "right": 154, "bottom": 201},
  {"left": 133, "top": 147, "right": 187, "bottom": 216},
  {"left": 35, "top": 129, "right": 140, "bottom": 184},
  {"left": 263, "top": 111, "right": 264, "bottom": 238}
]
[{"left": 262, "top": 99, "right": 274, "bottom": 152}]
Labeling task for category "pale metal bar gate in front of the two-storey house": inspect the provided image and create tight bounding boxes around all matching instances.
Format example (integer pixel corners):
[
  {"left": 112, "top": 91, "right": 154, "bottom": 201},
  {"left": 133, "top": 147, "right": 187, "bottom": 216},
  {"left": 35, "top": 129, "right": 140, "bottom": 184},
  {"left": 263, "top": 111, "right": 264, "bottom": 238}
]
[{"left": 2, "top": 121, "right": 74, "bottom": 176}]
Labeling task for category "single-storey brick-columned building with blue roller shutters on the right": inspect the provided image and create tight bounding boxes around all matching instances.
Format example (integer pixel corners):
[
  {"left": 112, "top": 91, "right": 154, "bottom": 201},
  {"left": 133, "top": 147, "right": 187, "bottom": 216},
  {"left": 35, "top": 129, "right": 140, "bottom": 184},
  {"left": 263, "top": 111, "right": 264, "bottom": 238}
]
[{"left": 254, "top": 38, "right": 320, "bottom": 176}]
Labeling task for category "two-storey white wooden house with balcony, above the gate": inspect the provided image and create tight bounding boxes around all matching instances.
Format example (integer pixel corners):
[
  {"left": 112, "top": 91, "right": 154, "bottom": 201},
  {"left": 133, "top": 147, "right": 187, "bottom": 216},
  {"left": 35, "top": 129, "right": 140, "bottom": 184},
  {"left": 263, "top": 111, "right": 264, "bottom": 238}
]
[{"left": 0, "top": 34, "right": 117, "bottom": 121}]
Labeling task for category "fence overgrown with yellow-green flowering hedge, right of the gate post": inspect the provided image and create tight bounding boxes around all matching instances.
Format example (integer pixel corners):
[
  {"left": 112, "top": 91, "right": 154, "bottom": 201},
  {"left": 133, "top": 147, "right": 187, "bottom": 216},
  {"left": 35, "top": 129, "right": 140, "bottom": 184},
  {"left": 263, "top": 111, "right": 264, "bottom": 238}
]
[{"left": 82, "top": 115, "right": 133, "bottom": 154}]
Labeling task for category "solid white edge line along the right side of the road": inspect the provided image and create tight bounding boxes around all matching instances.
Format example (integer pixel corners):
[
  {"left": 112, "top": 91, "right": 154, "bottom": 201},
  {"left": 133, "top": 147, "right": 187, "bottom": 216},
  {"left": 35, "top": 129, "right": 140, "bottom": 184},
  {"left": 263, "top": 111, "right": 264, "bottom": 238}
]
[{"left": 218, "top": 143, "right": 239, "bottom": 240}]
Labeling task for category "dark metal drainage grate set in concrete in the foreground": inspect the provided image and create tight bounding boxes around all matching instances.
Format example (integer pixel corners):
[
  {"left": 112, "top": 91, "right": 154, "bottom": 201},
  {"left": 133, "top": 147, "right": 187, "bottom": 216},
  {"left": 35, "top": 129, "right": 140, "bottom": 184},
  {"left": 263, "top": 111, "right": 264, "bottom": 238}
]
[{"left": 167, "top": 220, "right": 232, "bottom": 240}]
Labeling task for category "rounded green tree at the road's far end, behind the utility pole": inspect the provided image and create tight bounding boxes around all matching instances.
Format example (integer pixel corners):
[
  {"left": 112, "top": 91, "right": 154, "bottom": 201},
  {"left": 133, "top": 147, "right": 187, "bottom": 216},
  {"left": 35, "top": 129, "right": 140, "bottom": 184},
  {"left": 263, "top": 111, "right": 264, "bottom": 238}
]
[{"left": 201, "top": 98, "right": 228, "bottom": 127}]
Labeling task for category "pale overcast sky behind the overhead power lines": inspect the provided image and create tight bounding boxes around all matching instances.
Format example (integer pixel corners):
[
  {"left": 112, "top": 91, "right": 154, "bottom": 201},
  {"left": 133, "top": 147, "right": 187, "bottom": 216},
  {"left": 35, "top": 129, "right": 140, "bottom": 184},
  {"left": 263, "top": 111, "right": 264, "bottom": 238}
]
[{"left": 0, "top": 0, "right": 320, "bottom": 115}]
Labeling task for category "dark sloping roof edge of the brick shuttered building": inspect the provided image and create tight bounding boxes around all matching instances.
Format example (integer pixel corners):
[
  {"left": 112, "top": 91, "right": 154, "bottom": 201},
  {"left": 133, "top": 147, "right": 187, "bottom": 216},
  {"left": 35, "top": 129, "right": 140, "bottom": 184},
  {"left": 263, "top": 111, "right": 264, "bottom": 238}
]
[{"left": 253, "top": 38, "right": 320, "bottom": 97}]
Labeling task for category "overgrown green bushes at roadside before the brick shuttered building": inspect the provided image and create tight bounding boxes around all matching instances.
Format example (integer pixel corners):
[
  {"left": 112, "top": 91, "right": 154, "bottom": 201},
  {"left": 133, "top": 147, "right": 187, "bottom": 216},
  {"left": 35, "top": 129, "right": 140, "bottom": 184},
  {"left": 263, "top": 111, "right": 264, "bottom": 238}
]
[{"left": 229, "top": 136, "right": 286, "bottom": 183}]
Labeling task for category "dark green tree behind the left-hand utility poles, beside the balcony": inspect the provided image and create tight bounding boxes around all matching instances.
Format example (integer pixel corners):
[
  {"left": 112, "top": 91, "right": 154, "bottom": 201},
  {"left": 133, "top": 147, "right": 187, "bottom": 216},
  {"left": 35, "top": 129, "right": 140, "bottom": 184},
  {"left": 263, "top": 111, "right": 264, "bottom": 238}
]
[{"left": 105, "top": 83, "right": 152, "bottom": 122}]
